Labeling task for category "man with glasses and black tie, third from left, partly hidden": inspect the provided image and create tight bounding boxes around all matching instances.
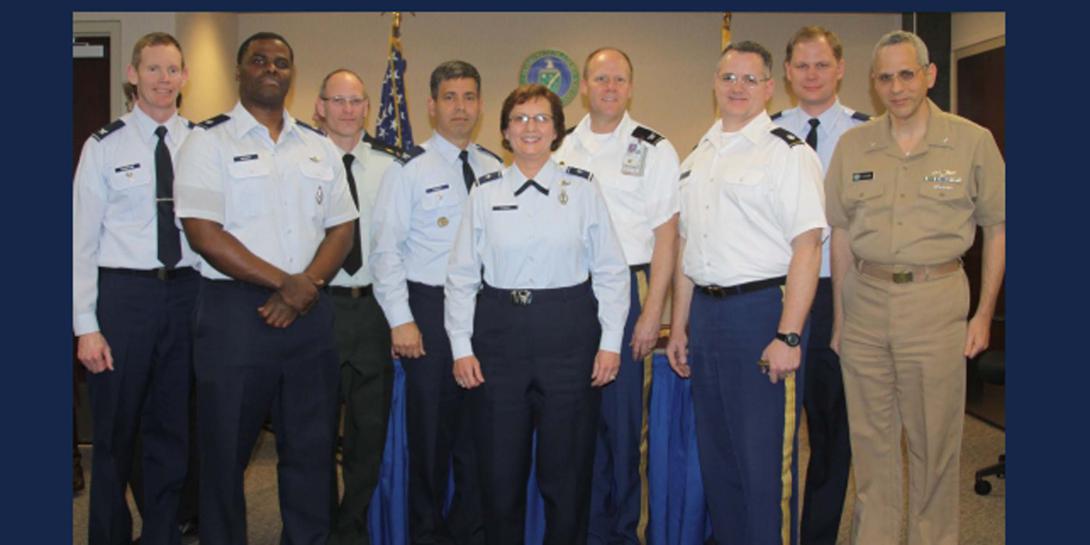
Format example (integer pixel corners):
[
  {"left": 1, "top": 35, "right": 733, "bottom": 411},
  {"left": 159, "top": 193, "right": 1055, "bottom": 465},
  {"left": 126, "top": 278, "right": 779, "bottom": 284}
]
[{"left": 314, "top": 69, "right": 403, "bottom": 545}]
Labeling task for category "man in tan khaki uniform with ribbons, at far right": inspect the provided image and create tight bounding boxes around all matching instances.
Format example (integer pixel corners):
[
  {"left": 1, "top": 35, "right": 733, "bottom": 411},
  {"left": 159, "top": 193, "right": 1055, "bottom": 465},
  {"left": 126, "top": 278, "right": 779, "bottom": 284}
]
[{"left": 825, "top": 31, "right": 1006, "bottom": 545}]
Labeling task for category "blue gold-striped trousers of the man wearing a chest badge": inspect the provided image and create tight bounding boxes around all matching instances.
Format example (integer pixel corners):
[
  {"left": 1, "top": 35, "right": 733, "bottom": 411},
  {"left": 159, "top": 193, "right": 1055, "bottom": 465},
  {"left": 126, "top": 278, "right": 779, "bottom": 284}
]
[{"left": 588, "top": 265, "right": 651, "bottom": 545}]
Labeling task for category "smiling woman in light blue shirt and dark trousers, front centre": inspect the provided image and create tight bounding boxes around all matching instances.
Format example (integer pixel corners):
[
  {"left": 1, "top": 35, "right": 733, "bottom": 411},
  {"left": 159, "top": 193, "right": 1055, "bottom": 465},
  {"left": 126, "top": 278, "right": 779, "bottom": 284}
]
[{"left": 446, "top": 84, "right": 629, "bottom": 545}]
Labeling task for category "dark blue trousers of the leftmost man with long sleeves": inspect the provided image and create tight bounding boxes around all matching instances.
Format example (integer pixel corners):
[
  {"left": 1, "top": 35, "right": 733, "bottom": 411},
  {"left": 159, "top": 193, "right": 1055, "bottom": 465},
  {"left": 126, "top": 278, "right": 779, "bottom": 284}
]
[{"left": 87, "top": 268, "right": 198, "bottom": 545}]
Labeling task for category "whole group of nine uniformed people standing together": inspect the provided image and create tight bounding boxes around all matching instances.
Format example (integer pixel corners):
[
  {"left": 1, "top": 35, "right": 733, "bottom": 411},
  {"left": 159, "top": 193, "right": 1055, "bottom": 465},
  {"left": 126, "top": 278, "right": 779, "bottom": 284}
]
[{"left": 73, "top": 22, "right": 1005, "bottom": 545}]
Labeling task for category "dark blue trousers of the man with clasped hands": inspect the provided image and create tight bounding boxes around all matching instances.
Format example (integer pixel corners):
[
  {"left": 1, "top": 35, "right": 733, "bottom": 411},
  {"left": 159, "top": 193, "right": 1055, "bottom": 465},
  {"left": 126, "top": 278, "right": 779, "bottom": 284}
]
[{"left": 193, "top": 279, "right": 340, "bottom": 545}]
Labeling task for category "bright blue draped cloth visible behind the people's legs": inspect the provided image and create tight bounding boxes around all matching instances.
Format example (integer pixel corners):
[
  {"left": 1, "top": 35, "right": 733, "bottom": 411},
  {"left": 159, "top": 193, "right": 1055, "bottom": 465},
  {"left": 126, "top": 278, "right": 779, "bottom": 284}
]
[{"left": 368, "top": 354, "right": 711, "bottom": 545}]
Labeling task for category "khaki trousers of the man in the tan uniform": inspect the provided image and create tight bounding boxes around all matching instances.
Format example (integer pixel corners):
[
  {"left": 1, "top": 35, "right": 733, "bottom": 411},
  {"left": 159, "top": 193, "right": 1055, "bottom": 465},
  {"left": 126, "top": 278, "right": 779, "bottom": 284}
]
[{"left": 840, "top": 264, "right": 969, "bottom": 545}]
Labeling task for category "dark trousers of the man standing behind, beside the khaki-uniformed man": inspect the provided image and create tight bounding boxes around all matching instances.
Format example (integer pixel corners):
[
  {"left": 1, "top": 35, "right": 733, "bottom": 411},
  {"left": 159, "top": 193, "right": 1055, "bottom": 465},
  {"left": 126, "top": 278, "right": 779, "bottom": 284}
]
[{"left": 799, "top": 278, "right": 851, "bottom": 545}]
